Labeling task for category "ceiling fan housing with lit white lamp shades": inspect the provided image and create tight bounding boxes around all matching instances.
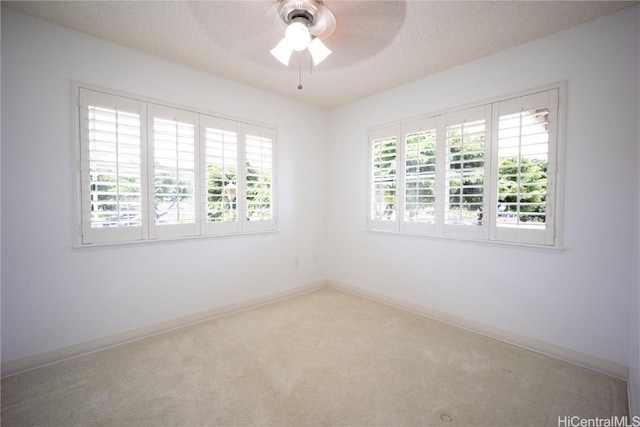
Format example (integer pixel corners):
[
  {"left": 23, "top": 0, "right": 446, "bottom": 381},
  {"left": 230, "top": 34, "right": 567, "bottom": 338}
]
[{"left": 271, "top": 0, "right": 336, "bottom": 66}]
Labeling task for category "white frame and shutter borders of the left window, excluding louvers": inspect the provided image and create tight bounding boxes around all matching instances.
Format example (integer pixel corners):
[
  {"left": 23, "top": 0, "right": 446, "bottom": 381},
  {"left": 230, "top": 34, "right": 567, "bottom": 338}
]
[{"left": 71, "top": 81, "right": 278, "bottom": 247}]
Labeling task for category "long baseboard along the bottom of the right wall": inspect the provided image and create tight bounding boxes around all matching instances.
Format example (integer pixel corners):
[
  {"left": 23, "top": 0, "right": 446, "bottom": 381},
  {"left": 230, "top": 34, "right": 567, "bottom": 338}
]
[{"left": 327, "top": 280, "right": 629, "bottom": 381}]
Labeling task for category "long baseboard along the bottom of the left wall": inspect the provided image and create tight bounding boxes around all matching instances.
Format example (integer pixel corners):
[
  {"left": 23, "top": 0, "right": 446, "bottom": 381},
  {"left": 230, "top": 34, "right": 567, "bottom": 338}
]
[{"left": 1, "top": 281, "right": 326, "bottom": 377}]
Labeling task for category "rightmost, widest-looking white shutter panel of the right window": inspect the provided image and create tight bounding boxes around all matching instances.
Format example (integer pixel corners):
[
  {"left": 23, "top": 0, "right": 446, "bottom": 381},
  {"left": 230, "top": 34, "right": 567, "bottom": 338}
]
[{"left": 491, "top": 89, "right": 558, "bottom": 245}]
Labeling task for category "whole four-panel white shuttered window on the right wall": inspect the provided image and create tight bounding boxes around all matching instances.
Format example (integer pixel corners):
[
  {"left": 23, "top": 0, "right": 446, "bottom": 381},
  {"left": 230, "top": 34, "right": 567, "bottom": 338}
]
[{"left": 368, "top": 86, "right": 560, "bottom": 246}]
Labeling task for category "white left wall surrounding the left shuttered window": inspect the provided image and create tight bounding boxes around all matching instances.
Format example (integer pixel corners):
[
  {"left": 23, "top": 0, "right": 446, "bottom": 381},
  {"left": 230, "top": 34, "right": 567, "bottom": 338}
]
[{"left": 2, "top": 8, "right": 327, "bottom": 362}]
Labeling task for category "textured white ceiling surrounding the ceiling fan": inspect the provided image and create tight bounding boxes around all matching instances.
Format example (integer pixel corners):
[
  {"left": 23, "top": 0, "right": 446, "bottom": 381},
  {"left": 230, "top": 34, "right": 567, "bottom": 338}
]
[{"left": 2, "top": 0, "right": 638, "bottom": 108}]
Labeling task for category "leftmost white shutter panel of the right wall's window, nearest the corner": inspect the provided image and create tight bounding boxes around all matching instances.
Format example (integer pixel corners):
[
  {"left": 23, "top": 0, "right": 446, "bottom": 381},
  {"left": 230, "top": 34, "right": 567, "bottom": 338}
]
[{"left": 369, "top": 126, "right": 401, "bottom": 231}]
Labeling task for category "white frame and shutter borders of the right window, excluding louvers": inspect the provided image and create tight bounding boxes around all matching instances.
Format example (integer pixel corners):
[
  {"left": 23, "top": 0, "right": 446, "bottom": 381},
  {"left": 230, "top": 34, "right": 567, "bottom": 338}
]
[{"left": 365, "top": 81, "right": 567, "bottom": 249}]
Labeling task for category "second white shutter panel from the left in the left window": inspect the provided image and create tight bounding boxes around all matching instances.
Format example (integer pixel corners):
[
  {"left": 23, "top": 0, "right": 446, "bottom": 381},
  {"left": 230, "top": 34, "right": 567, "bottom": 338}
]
[{"left": 148, "top": 104, "right": 200, "bottom": 238}]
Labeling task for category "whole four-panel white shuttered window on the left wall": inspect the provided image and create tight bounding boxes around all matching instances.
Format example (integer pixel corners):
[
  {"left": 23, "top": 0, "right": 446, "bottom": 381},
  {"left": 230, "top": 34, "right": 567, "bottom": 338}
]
[{"left": 76, "top": 85, "right": 275, "bottom": 244}]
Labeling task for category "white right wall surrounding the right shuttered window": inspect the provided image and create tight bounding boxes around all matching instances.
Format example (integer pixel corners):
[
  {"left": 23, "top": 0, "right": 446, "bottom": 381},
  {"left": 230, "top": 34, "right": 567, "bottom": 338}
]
[{"left": 327, "top": 7, "right": 639, "bottom": 366}]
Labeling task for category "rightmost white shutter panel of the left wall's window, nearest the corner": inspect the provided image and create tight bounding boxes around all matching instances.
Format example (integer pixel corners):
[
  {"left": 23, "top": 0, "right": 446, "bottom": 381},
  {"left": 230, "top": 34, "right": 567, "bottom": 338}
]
[{"left": 243, "top": 125, "right": 275, "bottom": 231}]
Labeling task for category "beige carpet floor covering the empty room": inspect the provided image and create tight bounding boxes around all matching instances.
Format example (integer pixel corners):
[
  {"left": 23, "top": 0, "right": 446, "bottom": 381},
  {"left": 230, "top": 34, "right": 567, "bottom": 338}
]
[{"left": 2, "top": 289, "right": 627, "bottom": 427}]
